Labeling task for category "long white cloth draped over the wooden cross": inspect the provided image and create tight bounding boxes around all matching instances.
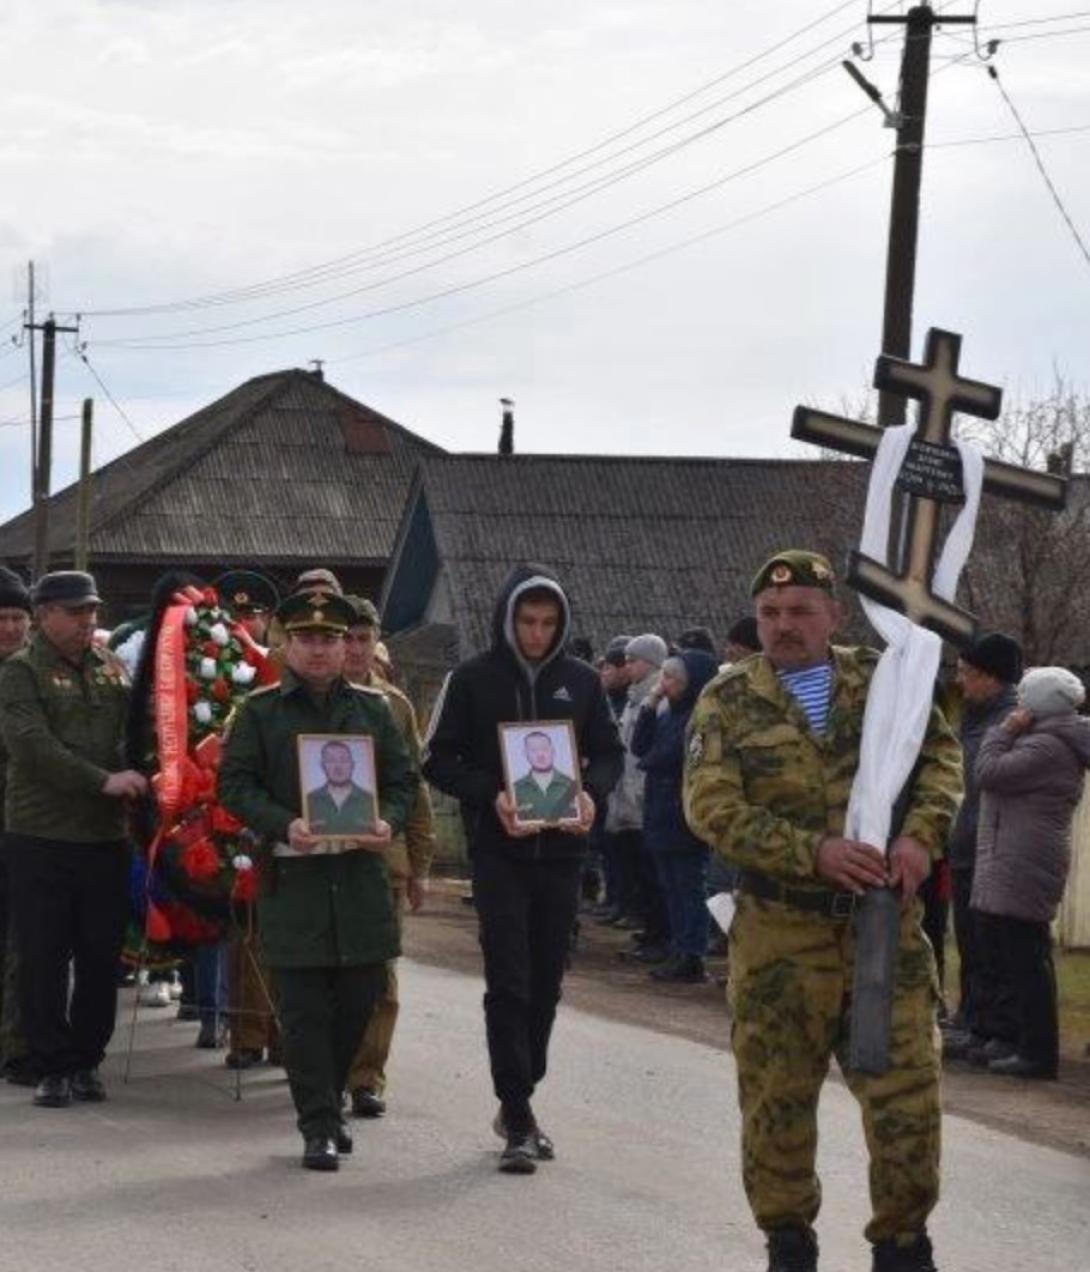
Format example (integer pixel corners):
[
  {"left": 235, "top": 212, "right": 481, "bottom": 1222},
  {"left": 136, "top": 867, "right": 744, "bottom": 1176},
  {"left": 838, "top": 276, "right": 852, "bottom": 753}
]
[{"left": 845, "top": 425, "right": 984, "bottom": 851}]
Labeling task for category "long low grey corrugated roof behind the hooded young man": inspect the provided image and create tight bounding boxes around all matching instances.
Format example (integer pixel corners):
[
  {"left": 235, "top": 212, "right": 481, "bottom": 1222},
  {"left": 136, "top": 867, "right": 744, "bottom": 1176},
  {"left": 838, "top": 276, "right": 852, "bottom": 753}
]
[{"left": 387, "top": 455, "right": 1090, "bottom": 665}]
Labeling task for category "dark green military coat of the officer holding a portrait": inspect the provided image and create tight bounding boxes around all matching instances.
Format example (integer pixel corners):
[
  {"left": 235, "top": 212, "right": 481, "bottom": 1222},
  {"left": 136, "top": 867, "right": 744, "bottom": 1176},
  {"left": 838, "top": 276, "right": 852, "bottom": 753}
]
[{"left": 219, "top": 670, "right": 420, "bottom": 967}]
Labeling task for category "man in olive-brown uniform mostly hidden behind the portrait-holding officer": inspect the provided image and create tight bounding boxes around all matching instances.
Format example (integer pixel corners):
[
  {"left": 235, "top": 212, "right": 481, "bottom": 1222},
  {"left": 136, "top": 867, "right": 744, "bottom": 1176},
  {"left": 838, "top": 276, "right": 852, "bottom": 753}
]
[{"left": 345, "top": 597, "right": 435, "bottom": 1117}]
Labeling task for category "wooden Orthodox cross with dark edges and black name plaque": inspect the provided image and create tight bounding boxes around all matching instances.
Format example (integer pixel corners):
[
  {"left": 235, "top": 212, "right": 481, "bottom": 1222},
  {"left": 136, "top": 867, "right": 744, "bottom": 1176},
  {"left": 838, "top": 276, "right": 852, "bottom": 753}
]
[{"left": 791, "top": 328, "right": 1067, "bottom": 1074}]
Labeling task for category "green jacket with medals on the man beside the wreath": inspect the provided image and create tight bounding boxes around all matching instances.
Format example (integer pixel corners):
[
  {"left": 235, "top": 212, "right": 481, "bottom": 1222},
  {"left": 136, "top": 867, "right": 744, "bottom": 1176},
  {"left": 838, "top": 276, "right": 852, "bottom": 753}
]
[{"left": 0, "top": 632, "right": 128, "bottom": 843}]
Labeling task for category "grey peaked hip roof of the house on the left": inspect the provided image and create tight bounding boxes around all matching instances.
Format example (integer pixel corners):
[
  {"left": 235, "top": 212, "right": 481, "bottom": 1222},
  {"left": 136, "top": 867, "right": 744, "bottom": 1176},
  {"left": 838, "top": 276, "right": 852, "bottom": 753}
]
[{"left": 0, "top": 370, "right": 443, "bottom": 563}]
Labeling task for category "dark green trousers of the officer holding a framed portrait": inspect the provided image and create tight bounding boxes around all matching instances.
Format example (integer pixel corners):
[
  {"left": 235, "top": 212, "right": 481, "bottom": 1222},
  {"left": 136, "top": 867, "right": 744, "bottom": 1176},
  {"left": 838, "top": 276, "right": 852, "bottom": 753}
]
[{"left": 276, "top": 963, "right": 387, "bottom": 1138}]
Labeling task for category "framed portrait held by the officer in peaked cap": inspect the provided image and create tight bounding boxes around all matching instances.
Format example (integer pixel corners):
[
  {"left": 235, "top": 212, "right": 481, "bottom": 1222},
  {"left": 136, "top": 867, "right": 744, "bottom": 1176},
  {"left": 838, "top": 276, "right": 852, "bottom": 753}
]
[{"left": 298, "top": 733, "right": 379, "bottom": 843}]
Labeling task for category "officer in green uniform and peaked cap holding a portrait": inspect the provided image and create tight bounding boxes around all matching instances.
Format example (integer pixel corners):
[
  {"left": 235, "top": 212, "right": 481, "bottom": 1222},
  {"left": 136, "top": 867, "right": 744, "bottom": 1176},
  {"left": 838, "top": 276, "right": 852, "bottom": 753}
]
[{"left": 219, "top": 589, "right": 418, "bottom": 1170}]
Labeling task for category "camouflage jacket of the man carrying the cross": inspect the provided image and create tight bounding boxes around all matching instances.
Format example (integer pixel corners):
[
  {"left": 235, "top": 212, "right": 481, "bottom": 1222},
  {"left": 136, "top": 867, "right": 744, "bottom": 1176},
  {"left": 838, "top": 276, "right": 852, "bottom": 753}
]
[{"left": 683, "top": 646, "right": 962, "bottom": 885}]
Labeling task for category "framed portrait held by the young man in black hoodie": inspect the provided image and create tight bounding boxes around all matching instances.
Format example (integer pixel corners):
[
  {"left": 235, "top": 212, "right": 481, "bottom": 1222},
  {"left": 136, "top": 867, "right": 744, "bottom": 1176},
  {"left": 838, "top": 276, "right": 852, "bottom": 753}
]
[{"left": 500, "top": 720, "right": 583, "bottom": 826}]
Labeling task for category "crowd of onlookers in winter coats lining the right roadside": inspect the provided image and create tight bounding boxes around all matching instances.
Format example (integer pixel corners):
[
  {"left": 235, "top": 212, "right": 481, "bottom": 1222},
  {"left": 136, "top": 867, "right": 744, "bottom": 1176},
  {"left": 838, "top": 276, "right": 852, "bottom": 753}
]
[{"left": 569, "top": 618, "right": 1090, "bottom": 1077}]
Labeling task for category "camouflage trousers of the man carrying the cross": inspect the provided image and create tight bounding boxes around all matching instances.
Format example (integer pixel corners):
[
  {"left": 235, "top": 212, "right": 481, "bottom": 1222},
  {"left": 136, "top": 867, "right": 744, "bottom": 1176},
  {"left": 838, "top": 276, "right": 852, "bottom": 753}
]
[{"left": 729, "top": 895, "right": 941, "bottom": 1241}]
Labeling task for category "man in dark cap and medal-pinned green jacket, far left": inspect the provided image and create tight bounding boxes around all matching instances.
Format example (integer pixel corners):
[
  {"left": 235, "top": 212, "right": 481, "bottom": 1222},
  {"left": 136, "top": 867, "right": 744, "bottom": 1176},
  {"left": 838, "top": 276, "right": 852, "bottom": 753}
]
[{"left": 0, "top": 570, "right": 148, "bottom": 1108}]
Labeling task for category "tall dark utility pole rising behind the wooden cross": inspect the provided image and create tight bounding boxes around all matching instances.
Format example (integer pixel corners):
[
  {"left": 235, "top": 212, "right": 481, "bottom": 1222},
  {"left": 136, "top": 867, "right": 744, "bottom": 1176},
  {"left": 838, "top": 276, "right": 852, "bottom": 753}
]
[{"left": 856, "top": 3, "right": 977, "bottom": 427}]
